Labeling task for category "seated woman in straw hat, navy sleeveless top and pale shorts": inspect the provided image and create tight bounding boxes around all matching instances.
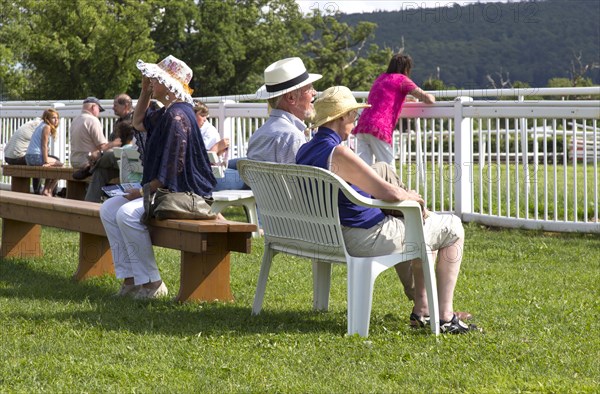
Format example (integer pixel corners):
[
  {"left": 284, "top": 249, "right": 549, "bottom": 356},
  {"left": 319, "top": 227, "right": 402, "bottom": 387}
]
[{"left": 296, "top": 86, "right": 477, "bottom": 334}]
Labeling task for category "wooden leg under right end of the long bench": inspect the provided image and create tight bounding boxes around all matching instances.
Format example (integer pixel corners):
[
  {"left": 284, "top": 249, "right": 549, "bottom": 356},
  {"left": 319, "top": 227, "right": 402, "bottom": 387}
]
[{"left": 175, "top": 234, "right": 233, "bottom": 302}]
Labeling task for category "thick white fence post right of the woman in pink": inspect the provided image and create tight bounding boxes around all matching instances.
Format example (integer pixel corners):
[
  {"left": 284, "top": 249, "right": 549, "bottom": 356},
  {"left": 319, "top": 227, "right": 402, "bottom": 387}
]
[{"left": 454, "top": 97, "right": 473, "bottom": 219}]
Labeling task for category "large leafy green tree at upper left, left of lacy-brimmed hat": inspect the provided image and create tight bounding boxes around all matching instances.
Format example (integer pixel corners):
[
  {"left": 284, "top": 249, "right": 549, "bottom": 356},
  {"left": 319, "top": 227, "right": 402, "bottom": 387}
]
[{"left": 1, "top": 0, "right": 154, "bottom": 99}]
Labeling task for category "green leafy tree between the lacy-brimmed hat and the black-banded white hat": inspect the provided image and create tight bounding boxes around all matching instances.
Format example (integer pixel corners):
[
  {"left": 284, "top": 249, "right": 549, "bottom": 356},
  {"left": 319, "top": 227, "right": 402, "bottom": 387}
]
[{"left": 184, "top": 0, "right": 304, "bottom": 96}]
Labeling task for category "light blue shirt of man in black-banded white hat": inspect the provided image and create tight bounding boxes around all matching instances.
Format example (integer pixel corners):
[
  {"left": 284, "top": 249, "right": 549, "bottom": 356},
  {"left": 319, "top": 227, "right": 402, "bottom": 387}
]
[{"left": 247, "top": 109, "right": 306, "bottom": 164}]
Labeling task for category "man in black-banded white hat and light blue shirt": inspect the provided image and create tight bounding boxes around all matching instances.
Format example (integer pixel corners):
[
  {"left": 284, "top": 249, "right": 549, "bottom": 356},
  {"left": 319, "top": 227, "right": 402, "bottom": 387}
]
[{"left": 248, "top": 57, "right": 322, "bottom": 163}]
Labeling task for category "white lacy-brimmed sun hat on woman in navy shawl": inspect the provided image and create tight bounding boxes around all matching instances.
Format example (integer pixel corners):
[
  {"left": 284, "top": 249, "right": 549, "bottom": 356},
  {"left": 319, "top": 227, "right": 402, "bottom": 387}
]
[{"left": 136, "top": 55, "right": 193, "bottom": 104}]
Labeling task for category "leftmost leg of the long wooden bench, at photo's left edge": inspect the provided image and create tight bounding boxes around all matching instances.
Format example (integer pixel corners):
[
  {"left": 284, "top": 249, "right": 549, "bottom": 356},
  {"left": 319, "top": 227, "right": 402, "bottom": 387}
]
[{"left": 0, "top": 219, "right": 43, "bottom": 258}]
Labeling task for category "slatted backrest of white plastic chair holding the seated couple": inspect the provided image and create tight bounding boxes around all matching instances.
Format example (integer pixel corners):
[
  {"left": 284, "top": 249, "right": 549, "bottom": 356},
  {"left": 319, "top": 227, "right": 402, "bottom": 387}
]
[{"left": 238, "top": 160, "right": 347, "bottom": 262}]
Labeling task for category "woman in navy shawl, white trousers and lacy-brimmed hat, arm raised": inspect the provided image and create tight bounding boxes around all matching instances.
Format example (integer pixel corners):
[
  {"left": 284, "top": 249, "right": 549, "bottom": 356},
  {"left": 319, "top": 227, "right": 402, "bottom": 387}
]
[{"left": 100, "top": 56, "right": 216, "bottom": 298}]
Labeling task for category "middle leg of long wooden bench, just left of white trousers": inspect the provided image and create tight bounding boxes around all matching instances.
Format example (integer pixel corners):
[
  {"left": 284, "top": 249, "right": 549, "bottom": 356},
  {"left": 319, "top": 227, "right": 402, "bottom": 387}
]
[{"left": 73, "top": 233, "right": 115, "bottom": 281}]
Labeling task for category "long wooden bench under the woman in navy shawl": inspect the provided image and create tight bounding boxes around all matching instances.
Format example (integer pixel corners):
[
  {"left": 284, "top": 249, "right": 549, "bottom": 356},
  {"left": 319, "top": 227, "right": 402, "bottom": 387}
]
[{"left": 0, "top": 191, "right": 256, "bottom": 301}]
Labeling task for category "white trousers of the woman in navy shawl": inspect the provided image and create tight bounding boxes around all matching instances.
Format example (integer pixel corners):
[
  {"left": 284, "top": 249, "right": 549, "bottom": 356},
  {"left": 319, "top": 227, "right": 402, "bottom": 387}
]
[{"left": 100, "top": 196, "right": 160, "bottom": 285}]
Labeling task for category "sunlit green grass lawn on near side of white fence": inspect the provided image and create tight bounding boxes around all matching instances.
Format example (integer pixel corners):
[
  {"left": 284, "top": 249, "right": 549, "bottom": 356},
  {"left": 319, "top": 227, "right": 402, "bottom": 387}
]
[{"left": 0, "top": 214, "right": 600, "bottom": 393}]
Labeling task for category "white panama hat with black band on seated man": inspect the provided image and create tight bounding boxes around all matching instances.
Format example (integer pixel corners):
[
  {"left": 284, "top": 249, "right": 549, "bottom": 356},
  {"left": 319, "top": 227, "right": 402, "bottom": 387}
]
[{"left": 256, "top": 57, "right": 323, "bottom": 100}]
